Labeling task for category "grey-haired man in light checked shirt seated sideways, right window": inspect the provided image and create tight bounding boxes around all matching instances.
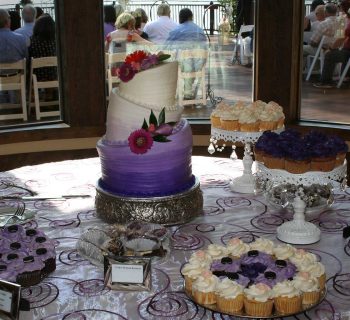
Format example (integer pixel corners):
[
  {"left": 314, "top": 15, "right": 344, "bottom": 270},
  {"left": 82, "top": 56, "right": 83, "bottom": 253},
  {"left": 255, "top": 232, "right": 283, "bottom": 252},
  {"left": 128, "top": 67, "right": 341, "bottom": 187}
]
[{"left": 303, "top": 3, "right": 338, "bottom": 70}]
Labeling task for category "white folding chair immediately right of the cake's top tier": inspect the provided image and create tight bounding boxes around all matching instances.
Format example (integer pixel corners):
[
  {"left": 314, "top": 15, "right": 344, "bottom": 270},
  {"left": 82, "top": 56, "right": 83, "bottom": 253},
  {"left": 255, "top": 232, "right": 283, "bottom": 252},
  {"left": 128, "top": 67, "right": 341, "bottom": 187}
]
[{"left": 177, "top": 49, "right": 208, "bottom": 106}]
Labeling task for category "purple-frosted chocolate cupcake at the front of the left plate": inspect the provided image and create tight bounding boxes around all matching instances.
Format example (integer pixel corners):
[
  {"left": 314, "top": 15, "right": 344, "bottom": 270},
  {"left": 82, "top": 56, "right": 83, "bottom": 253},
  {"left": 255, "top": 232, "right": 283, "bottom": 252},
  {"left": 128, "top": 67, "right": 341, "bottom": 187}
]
[{"left": 17, "top": 256, "right": 44, "bottom": 287}]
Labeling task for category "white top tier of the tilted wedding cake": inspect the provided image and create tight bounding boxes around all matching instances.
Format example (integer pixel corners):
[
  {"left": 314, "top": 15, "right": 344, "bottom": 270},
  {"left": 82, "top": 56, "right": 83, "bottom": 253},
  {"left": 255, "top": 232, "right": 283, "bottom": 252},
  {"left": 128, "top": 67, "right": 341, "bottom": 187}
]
[{"left": 119, "top": 61, "right": 178, "bottom": 111}]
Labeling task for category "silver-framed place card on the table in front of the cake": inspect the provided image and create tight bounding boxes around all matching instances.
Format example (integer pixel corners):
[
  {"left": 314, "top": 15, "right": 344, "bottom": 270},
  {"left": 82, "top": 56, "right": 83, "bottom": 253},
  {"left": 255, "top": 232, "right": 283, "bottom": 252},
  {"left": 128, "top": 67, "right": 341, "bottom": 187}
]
[{"left": 104, "top": 254, "right": 152, "bottom": 291}]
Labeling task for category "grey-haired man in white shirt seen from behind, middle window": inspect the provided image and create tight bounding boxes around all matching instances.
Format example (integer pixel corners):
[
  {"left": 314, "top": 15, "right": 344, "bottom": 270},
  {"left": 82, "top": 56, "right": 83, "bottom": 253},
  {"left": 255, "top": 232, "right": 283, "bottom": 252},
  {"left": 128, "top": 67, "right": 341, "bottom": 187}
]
[{"left": 143, "top": 3, "right": 177, "bottom": 44}]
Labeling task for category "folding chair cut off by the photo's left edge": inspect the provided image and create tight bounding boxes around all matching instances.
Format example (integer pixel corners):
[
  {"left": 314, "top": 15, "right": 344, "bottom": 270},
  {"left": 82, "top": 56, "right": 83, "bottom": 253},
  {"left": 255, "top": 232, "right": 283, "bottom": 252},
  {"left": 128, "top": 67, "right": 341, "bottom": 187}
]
[{"left": 0, "top": 59, "right": 28, "bottom": 121}]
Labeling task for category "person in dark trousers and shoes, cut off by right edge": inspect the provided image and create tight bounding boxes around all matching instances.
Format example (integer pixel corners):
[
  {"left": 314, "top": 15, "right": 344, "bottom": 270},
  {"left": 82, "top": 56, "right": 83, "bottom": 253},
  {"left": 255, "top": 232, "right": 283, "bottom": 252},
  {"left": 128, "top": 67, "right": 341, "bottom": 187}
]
[{"left": 314, "top": 0, "right": 350, "bottom": 89}]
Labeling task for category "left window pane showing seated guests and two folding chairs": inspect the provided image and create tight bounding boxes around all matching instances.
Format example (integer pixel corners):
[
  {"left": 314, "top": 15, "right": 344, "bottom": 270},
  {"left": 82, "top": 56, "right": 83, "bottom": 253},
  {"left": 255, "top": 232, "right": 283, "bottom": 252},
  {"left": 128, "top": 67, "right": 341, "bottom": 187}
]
[{"left": 0, "top": 1, "right": 61, "bottom": 128}]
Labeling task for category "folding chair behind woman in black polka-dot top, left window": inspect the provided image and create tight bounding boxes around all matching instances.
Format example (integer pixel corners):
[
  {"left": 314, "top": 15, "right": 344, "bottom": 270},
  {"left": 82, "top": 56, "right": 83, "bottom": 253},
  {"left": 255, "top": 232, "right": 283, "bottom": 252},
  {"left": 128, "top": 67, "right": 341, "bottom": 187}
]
[{"left": 29, "top": 56, "right": 61, "bottom": 120}]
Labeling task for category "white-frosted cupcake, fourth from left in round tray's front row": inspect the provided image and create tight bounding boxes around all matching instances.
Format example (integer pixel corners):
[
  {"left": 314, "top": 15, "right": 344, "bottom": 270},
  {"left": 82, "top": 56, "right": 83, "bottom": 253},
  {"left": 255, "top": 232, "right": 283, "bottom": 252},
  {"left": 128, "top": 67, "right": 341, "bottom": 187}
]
[{"left": 272, "top": 280, "right": 302, "bottom": 314}]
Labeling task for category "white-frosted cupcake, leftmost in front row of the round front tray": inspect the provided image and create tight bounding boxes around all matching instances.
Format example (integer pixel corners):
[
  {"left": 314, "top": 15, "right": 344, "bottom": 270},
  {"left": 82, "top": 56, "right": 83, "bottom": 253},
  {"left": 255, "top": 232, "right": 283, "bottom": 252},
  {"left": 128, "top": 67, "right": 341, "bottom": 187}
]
[{"left": 192, "top": 270, "right": 219, "bottom": 304}]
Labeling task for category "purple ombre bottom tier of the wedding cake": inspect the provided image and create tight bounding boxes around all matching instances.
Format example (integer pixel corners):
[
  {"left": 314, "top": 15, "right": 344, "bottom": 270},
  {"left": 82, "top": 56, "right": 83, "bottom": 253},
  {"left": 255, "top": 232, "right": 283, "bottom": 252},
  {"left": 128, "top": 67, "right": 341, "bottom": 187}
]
[{"left": 97, "top": 119, "right": 195, "bottom": 197}]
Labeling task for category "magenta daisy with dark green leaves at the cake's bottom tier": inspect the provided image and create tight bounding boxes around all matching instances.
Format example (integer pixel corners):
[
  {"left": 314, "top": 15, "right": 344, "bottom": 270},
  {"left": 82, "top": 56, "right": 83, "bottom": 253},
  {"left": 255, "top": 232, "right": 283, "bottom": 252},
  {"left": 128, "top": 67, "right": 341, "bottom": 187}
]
[{"left": 128, "top": 108, "right": 175, "bottom": 154}]
